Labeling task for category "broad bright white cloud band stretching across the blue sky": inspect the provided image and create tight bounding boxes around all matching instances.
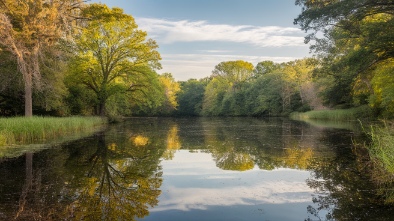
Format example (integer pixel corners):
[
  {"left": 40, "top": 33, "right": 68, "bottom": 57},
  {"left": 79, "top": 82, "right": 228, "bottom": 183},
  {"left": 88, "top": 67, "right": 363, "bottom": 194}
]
[{"left": 137, "top": 18, "right": 304, "bottom": 47}]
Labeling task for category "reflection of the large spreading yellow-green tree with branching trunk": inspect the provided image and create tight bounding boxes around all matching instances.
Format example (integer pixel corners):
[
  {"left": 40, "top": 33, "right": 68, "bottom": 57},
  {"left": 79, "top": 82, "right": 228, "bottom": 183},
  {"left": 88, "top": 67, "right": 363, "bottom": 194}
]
[{"left": 63, "top": 132, "right": 162, "bottom": 220}]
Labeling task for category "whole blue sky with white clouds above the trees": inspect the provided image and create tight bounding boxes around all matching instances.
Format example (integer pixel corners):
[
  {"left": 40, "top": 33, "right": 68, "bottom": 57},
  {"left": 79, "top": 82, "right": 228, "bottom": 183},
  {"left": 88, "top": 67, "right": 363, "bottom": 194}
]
[{"left": 90, "top": 0, "right": 310, "bottom": 81}]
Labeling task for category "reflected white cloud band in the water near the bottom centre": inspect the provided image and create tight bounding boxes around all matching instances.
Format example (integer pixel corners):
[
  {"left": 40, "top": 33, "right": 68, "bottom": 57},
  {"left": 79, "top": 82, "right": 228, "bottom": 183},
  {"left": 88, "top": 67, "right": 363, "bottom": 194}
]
[{"left": 152, "top": 183, "right": 313, "bottom": 212}]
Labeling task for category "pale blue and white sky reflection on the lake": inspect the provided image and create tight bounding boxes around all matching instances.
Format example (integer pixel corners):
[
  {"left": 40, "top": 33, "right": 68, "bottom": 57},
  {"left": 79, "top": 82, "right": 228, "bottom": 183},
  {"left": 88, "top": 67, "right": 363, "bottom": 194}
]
[{"left": 143, "top": 150, "right": 313, "bottom": 220}]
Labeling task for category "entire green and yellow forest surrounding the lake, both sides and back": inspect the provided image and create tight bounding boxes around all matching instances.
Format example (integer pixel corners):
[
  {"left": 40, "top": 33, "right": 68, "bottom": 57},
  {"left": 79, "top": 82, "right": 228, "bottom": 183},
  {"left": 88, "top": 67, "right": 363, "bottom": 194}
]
[{"left": 0, "top": 0, "right": 394, "bottom": 121}]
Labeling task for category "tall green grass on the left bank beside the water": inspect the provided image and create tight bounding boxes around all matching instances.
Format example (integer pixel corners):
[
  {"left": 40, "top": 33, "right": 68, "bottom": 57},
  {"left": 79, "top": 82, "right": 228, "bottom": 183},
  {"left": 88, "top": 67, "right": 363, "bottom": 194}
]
[{"left": 0, "top": 117, "right": 106, "bottom": 146}]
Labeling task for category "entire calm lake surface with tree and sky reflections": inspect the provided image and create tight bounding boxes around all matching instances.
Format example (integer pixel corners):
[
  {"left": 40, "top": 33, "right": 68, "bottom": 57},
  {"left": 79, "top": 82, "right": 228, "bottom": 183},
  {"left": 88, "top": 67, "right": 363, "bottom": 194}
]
[{"left": 0, "top": 118, "right": 394, "bottom": 221}]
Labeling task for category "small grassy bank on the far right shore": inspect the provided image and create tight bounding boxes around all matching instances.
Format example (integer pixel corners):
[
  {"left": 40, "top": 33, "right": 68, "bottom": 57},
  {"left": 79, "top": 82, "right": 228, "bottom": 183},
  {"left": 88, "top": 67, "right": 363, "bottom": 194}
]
[{"left": 290, "top": 106, "right": 373, "bottom": 121}]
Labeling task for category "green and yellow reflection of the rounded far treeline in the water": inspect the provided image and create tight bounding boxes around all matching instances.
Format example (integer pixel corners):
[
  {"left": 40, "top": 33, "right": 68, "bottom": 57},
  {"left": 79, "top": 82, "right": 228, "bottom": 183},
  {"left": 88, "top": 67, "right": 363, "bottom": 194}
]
[{"left": 195, "top": 118, "right": 333, "bottom": 171}]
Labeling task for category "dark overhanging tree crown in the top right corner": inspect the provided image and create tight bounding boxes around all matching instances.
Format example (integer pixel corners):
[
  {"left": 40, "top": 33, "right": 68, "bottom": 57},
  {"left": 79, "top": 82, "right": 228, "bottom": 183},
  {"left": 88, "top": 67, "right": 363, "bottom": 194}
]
[{"left": 294, "top": 0, "right": 394, "bottom": 72}]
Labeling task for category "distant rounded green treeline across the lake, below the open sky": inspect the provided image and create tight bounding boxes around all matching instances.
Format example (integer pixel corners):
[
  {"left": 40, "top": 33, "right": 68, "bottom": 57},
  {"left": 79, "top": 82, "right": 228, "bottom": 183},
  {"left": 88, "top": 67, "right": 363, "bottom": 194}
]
[{"left": 175, "top": 59, "right": 321, "bottom": 116}]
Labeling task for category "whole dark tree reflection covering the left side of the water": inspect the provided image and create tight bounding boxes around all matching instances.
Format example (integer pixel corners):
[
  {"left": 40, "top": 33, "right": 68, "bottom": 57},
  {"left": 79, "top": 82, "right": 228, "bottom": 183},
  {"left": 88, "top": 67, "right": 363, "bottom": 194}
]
[{"left": 0, "top": 120, "right": 164, "bottom": 220}]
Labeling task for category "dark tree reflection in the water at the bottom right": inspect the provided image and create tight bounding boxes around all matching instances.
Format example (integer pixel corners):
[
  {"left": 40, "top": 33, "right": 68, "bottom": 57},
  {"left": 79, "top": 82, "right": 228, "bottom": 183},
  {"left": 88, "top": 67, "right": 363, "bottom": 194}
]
[{"left": 307, "top": 132, "right": 394, "bottom": 221}]
